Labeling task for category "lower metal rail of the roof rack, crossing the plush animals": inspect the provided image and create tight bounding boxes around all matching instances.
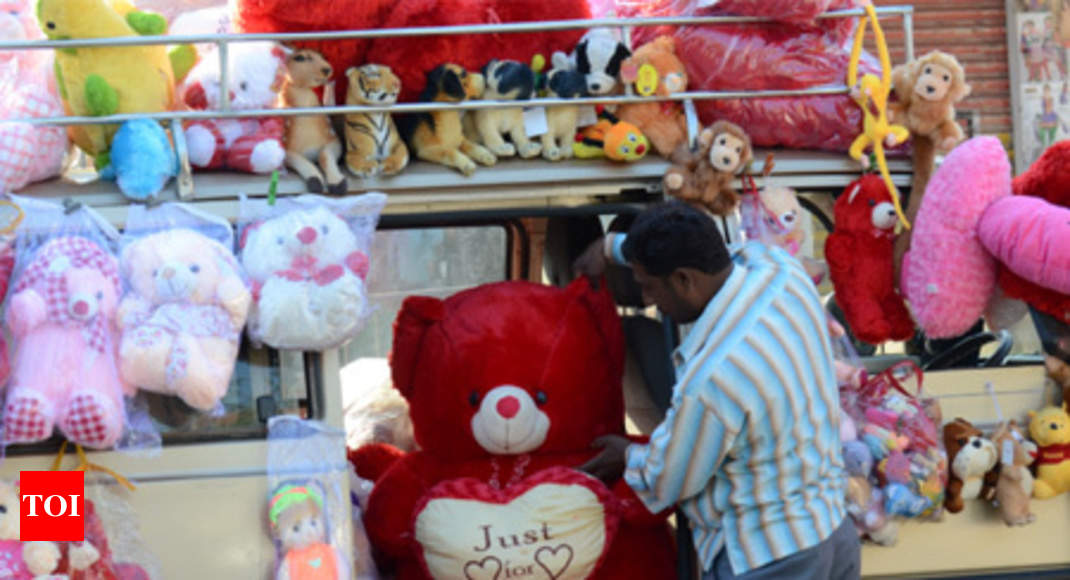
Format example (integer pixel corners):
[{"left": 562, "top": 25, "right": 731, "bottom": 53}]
[{"left": 2, "top": 86, "right": 847, "bottom": 125}]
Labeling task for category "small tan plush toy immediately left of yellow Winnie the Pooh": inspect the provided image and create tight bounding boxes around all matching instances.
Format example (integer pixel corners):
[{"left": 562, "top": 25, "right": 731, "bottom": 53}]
[{"left": 992, "top": 421, "right": 1037, "bottom": 525}]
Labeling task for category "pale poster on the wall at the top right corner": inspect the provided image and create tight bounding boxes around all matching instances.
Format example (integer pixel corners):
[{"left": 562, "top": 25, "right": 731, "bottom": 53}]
[{"left": 1007, "top": 0, "right": 1070, "bottom": 172}]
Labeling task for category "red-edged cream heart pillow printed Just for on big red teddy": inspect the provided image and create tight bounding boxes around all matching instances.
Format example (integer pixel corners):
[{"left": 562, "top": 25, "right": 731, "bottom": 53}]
[{"left": 413, "top": 467, "right": 620, "bottom": 580}]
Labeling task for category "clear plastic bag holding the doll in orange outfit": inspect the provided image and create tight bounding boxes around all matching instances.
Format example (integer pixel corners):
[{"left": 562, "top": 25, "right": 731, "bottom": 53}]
[{"left": 266, "top": 415, "right": 355, "bottom": 580}]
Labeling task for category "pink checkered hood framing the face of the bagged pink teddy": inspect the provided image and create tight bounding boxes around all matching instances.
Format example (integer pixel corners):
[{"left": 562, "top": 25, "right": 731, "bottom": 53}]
[{"left": 15, "top": 235, "right": 120, "bottom": 353}]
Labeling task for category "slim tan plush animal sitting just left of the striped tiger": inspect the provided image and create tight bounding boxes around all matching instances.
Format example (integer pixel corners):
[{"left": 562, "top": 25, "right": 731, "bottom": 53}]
[{"left": 282, "top": 50, "right": 346, "bottom": 194}]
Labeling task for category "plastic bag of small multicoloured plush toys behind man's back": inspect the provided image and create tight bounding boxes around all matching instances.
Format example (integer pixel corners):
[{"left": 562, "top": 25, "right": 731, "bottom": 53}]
[{"left": 840, "top": 361, "right": 948, "bottom": 537}]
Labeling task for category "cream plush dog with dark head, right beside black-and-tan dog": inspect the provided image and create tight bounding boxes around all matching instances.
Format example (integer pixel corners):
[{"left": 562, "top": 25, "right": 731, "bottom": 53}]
[{"left": 464, "top": 59, "right": 542, "bottom": 159}]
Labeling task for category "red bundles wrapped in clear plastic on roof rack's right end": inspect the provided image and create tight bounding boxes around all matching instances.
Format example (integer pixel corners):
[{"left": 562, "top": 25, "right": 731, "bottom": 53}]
[{"left": 596, "top": 0, "right": 880, "bottom": 151}]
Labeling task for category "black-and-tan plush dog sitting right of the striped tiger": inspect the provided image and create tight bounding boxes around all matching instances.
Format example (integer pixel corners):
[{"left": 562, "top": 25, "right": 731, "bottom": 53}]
[{"left": 399, "top": 64, "right": 498, "bottom": 175}]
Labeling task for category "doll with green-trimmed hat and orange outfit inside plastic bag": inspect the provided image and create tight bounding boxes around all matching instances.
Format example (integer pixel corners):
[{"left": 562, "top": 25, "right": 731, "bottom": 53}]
[{"left": 268, "top": 484, "right": 350, "bottom": 580}]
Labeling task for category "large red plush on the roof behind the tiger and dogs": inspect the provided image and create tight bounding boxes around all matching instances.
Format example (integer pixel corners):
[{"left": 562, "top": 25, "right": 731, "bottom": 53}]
[{"left": 232, "top": 0, "right": 591, "bottom": 103}]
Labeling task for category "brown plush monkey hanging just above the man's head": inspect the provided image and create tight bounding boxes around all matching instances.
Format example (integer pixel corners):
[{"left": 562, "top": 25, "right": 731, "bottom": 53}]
[{"left": 662, "top": 121, "right": 753, "bottom": 215}]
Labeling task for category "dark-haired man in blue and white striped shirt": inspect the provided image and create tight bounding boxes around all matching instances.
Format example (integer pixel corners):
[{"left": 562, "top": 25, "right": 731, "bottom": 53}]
[{"left": 576, "top": 202, "right": 860, "bottom": 580}]
